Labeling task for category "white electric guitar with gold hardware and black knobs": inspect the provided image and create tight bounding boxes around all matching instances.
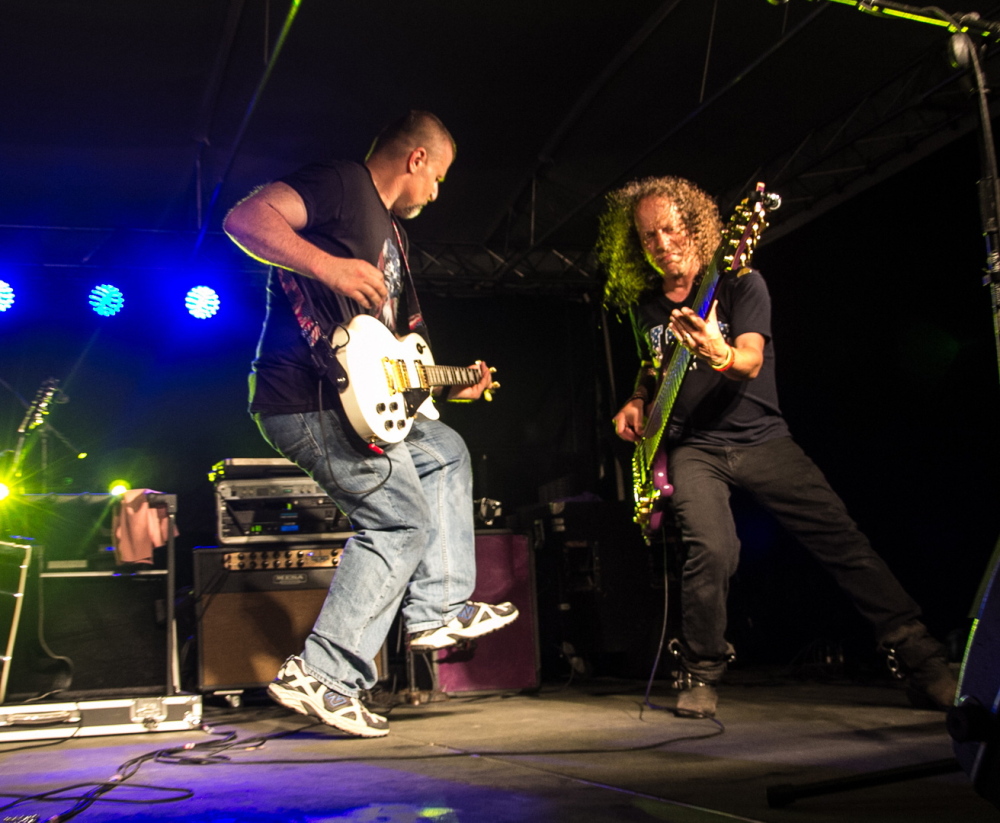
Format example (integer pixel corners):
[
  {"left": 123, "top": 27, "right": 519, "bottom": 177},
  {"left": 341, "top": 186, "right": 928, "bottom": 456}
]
[{"left": 330, "top": 314, "right": 496, "bottom": 443}]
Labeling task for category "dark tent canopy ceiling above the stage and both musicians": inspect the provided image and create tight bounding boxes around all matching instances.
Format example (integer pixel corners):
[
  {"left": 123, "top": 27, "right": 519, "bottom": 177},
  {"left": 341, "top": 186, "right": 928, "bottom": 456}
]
[{"left": 0, "top": 0, "right": 1000, "bottom": 290}]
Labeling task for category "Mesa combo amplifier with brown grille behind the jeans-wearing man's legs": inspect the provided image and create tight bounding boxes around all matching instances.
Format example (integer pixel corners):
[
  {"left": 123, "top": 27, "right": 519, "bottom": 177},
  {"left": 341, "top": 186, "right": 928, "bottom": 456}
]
[{"left": 193, "top": 542, "right": 343, "bottom": 692}]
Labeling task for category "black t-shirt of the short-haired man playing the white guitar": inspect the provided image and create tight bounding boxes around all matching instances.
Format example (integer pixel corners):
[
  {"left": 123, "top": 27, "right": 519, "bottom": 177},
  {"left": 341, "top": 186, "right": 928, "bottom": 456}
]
[{"left": 250, "top": 161, "right": 406, "bottom": 414}]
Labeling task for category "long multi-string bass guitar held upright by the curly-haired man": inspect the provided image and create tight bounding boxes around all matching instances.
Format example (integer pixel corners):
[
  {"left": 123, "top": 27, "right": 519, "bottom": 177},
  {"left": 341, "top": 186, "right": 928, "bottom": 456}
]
[{"left": 632, "top": 183, "right": 781, "bottom": 538}]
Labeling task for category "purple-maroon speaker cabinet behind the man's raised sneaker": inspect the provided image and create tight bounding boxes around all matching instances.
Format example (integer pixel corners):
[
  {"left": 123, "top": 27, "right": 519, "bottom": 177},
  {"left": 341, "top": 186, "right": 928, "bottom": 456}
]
[{"left": 435, "top": 530, "right": 539, "bottom": 694}]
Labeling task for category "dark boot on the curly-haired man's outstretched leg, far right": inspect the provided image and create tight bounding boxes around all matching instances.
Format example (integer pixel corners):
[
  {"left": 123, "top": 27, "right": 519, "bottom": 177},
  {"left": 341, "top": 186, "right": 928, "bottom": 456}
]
[{"left": 879, "top": 620, "right": 958, "bottom": 711}]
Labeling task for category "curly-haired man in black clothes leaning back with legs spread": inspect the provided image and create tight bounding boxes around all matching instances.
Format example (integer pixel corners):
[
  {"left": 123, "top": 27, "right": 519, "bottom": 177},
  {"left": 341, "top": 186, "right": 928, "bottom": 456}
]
[{"left": 598, "top": 177, "right": 956, "bottom": 717}]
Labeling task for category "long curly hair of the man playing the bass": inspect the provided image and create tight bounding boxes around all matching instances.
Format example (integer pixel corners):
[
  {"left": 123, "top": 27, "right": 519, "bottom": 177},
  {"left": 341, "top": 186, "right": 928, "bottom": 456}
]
[{"left": 597, "top": 176, "right": 722, "bottom": 310}]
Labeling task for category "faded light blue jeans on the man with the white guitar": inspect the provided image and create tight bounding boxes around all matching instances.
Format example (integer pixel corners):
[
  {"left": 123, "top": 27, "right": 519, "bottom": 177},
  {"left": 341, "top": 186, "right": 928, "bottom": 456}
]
[{"left": 255, "top": 409, "right": 476, "bottom": 696}]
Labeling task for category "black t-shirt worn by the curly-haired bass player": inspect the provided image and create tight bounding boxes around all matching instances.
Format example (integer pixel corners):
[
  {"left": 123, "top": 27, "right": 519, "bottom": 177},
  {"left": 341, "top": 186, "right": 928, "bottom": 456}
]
[{"left": 633, "top": 271, "right": 789, "bottom": 446}]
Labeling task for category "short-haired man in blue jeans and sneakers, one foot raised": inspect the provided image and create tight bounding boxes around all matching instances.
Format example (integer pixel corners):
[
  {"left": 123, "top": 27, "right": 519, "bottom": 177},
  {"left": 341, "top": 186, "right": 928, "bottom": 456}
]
[{"left": 224, "top": 111, "right": 518, "bottom": 737}]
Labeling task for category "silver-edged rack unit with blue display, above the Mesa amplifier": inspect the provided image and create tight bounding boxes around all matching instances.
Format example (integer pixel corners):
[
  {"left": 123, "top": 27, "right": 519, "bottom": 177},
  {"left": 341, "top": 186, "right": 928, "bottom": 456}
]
[{"left": 215, "top": 476, "right": 352, "bottom": 546}]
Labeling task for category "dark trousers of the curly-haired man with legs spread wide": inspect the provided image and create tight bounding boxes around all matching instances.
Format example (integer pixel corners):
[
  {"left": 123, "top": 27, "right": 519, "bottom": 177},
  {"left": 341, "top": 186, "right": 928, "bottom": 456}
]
[{"left": 669, "top": 437, "right": 920, "bottom": 680}]
